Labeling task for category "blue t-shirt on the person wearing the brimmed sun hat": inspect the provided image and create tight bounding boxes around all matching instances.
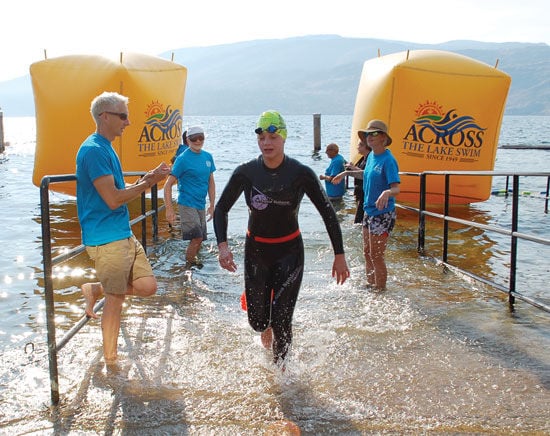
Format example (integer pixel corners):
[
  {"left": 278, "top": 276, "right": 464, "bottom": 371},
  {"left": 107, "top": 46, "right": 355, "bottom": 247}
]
[{"left": 363, "top": 149, "right": 401, "bottom": 216}]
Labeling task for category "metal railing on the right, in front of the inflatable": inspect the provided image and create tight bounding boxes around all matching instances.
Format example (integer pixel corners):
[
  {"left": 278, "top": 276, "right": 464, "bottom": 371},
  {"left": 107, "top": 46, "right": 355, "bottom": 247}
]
[{"left": 397, "top": 171, "right": 550, "bottom": 313}]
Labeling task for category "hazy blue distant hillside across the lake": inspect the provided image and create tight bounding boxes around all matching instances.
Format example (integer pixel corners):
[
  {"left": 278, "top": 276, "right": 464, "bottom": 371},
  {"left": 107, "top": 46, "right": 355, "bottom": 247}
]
[{"left": 0, "top": 35, "right": 550, "bottom": 116}]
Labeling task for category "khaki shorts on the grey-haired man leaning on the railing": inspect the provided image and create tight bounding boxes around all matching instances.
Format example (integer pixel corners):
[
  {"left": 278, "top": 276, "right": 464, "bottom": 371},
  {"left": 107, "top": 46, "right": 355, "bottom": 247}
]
[{"left": 86, "top": 235, "right": 153, "bottom": 295}]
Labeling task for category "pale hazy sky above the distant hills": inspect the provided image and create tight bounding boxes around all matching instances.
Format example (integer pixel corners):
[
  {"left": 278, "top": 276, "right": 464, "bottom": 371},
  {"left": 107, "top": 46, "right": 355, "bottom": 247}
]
[{"left": 0, "top": 0, "right": 550, "bottom": 81}]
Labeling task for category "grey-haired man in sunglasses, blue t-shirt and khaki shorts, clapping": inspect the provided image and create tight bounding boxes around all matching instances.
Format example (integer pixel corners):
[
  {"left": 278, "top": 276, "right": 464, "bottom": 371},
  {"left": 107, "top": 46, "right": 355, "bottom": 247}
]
[{"left": 76, "top": 92, "right": 170, "bottom": 364}]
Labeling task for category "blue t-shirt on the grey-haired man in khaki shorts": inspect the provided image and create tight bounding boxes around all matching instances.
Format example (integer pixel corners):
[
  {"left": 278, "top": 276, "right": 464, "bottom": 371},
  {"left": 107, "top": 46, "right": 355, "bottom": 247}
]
[{"left": 76, "top": 133, "right": 132, "bottom": 246}]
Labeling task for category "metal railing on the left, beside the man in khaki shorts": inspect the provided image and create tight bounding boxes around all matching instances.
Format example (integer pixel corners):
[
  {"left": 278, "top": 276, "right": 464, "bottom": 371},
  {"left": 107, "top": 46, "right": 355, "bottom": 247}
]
[{"left": 40, "top": 172, "right": 164, "bottom": 404}]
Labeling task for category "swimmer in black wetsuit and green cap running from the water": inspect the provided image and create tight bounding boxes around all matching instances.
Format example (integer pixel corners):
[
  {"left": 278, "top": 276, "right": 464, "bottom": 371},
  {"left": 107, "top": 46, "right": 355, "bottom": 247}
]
[{"left": 214, "top": 111, "right": 349, "bottom": 364}]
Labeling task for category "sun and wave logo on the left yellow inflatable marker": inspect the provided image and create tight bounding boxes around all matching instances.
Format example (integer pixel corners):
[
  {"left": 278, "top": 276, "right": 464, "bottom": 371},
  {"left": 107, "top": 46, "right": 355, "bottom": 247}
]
[{"left": 138, "top": 100, "right": 182, "bottom": 157}]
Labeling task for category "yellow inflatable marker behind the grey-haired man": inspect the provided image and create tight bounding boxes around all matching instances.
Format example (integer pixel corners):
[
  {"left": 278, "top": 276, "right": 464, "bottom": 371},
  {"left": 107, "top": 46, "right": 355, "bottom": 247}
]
[{"left": 30, "top": 53, "right": 187, "bottom": 195}]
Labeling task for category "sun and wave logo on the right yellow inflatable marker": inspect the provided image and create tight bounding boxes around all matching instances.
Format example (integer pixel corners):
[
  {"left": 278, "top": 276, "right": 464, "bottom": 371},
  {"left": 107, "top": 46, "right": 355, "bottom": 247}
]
[{"left": 403, "top": 100, "right": 487, "bottom": 162}]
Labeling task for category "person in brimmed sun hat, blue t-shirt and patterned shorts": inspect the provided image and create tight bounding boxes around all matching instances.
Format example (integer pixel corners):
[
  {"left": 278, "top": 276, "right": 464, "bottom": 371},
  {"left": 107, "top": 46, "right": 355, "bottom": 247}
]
[{"left": 357, "top": 120, "right": 400, "bottom": 291}]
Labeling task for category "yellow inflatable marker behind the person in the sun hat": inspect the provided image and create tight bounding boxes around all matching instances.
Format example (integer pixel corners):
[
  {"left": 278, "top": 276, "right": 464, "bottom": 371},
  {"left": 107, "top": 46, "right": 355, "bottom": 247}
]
[{"left": 350, "top": 50, "right": 511, "bottom": 204}]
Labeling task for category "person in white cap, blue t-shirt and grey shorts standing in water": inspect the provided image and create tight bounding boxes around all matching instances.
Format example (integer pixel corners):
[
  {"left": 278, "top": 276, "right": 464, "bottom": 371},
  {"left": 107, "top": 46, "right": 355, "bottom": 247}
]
[{"left": 164, "top": 126, "right": 216, "bottom": 266}]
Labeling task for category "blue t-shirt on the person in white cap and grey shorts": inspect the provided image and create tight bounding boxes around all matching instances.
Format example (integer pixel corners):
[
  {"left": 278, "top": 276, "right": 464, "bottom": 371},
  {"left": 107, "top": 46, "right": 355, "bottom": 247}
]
[{"left": 171, "top": 148, "right": 216, "bottom": 209}]
